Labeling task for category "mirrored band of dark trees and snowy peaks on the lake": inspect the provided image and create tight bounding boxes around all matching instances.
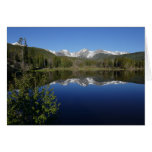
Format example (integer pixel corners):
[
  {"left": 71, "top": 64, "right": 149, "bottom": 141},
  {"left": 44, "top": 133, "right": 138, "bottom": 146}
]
[{"left": 34, "top": 71, "right": 144, "bottom": 86}]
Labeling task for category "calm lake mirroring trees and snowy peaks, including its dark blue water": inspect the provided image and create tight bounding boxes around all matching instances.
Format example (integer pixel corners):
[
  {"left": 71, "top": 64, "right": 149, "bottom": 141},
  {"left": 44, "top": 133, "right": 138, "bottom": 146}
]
[{"left": 7, "top": 71, "right": 145, "bottom": 125}]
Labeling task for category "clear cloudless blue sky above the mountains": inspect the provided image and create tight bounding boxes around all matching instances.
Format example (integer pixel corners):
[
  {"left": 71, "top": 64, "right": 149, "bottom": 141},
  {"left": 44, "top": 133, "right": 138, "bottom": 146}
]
[{"left": 7, "top": 27, "right": 145, "bottom": 52}]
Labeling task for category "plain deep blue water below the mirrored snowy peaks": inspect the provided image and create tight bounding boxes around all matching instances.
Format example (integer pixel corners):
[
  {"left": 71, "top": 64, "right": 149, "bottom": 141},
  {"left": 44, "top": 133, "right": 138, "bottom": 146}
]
[{"left": 50, "top": 83, "right": 145, "bottom": 125}]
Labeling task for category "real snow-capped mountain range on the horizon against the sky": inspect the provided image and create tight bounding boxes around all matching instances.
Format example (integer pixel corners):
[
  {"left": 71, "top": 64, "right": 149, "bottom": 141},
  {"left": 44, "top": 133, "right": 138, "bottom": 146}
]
[{"left": 50, "top": 49, "right": 129, "bottom": 58}]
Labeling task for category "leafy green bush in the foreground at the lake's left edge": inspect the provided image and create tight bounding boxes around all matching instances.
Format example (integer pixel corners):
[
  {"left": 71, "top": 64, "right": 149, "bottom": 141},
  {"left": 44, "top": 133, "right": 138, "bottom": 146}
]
[{"left": 7, "top": 74, "right": 60, "bottom": 125}]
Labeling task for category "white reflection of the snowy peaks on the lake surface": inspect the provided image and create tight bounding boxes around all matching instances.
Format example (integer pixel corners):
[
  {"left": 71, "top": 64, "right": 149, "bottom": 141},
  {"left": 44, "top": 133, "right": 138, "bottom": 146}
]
[{"left": 50, "top": 77, "right": 126, "bottom": 87}]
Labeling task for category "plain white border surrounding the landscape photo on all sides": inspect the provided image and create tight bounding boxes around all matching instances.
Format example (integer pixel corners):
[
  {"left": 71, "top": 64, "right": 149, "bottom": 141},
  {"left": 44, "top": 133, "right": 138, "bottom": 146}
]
[{"left": 0, "top": 0, "right": 152, "bottom": 152}]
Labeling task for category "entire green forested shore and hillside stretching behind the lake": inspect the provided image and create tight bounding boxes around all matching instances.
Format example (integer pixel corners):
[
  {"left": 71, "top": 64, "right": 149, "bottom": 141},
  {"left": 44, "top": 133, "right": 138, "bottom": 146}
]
[{"left": 7, "top": 44, "right": 144, "bottom": 71}]
